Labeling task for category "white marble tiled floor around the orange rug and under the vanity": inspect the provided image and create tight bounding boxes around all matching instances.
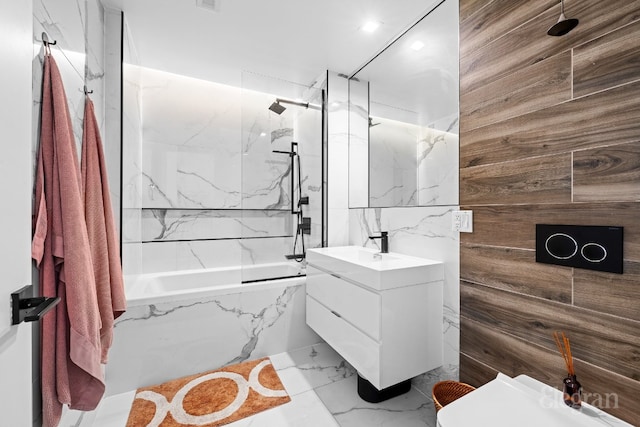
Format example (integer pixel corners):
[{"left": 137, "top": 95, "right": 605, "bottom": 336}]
[{"left": 60, "top": 343, "right": 436, "bottom": 427}]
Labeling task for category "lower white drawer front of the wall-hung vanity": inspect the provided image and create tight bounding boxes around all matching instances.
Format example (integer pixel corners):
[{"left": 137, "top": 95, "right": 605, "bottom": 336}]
[{"left": 307, "top": 295, "right": 380, "bottom": 385}]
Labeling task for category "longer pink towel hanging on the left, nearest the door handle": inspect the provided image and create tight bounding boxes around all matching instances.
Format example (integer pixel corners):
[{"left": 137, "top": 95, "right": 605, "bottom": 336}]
[{"left": 32, "top": 54, "right": 105, "bottom": 427}]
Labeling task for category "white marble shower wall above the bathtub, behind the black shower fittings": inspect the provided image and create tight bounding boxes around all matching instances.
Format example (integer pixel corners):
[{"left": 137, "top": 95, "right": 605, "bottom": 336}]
[{"left": 124, "top": 65, "right": 322, "bottom": 273}]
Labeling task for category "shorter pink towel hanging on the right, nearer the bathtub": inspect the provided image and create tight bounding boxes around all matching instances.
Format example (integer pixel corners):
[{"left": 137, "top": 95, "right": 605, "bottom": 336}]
[{"left": 82, "top": 96, "right": 126, "bottom": 363}]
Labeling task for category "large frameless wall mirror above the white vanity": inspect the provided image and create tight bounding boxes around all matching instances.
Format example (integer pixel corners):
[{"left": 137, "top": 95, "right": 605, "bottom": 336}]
[{"left": 349, "top": 0, "right": 459, "bottom": 208}]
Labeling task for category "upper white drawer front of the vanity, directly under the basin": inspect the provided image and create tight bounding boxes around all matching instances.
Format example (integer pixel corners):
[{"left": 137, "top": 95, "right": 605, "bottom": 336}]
[{"left": 307, "top": 266, "right": 381, "bottom": 341}]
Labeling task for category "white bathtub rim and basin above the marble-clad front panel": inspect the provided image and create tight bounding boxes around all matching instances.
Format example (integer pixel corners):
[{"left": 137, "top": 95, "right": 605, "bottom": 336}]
[{"left": 125, "top": 262, "right": 305, "bottom": 307}]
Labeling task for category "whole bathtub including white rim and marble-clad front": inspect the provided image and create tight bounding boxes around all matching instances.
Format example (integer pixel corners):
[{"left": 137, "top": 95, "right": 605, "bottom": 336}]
[{"left": 105, "top": 263, "right": 321, "bottom": 395}]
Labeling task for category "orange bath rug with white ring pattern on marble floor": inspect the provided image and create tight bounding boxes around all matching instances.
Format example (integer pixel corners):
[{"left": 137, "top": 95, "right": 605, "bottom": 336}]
[{"left": 127, "top": 357, "right": 291, "bottom": 427}]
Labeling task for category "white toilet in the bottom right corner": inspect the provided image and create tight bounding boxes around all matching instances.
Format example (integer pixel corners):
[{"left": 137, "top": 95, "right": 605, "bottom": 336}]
[{"left": 438, "top": 373, "right": 633, "bottom": 427}]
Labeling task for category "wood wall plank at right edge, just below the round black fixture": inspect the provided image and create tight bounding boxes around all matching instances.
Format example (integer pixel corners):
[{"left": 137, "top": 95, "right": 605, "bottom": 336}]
[{"left": 573, "top": 21, "right": 640, "bottom": 97}]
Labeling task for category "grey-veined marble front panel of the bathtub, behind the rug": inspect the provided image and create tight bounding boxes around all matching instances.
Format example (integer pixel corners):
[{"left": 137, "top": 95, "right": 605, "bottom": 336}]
[{"left": 106, "top": 284, "right": 320, "bottom": 395}]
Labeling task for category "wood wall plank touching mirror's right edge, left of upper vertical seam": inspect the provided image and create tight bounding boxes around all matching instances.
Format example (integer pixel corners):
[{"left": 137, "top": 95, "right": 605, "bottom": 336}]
[{"left": 460, "top": 51, "right": 571, "bottom": 132}]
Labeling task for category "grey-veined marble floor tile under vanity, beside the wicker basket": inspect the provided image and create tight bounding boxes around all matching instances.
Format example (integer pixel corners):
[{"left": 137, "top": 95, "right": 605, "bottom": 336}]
[{"left": 315, "top": 376, "right": 436, "bottom": 427}]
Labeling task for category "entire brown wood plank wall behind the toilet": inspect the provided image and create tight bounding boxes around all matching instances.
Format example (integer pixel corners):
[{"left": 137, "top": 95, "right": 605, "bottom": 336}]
[{"left": 460, "top": 0, "right": 640, "bottom": 425}]
